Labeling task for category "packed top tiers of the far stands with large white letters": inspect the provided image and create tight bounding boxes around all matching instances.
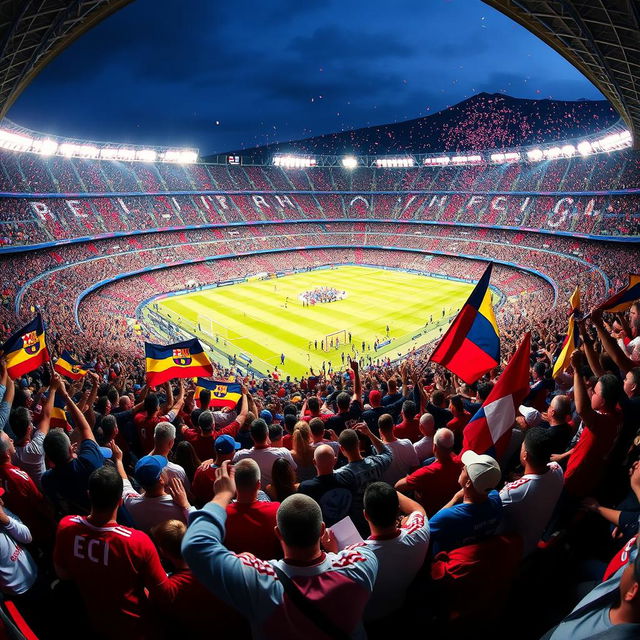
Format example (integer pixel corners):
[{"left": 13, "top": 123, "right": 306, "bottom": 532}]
[{"left": 0, "top": 151, "right": 640, "bottom": 244}]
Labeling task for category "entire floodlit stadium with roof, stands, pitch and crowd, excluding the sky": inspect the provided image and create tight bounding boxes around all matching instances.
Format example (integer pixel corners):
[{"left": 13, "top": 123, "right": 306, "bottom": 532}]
[{"left": 0, "top": 0, "right": 640, "bottom": 640}]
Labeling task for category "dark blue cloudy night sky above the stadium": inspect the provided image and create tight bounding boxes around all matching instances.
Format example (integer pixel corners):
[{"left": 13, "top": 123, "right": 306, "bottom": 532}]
[{"left": 8, "top": 0, "right": 602, "bottom": 155}]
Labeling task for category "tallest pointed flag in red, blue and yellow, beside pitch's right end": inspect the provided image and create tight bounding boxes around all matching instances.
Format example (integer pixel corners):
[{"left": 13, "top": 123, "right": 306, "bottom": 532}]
[{"left": 430, "top": 262, "right": 500, "bottom": 384}]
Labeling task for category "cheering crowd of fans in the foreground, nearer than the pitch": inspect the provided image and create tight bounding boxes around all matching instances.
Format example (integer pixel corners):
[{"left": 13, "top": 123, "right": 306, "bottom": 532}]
[{"left": 0, "top": 290, "right": 640, "bottom": 640}]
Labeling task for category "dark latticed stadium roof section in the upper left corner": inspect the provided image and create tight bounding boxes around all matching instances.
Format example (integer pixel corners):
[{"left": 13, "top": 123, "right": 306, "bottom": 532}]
[{"left": 0, "top": 0, "right": 131, "bottom": 118}]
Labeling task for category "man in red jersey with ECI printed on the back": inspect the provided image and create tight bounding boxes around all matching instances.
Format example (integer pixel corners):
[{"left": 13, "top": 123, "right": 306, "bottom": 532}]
[{"left": 53, "top": 466, "right": 175, "bottom": 640}]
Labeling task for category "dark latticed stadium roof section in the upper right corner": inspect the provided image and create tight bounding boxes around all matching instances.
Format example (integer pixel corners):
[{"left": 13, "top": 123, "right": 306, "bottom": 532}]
[{"left": 484, "top": 0, "right": 640, "bottom": 148}]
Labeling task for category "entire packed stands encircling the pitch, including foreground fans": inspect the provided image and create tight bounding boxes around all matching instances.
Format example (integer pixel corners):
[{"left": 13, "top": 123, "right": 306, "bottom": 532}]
[{"left": 0, "top": 100, "right": 640, "bottom": 640}]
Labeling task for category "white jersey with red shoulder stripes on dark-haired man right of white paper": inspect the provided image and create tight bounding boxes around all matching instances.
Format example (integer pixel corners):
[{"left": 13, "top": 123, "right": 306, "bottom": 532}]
[{"left": 358, "top": 511, "right": 430, "bottom": 620}]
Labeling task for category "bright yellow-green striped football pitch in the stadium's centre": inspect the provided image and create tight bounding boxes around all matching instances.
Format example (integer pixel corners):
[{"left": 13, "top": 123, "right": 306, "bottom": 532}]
[{"left": 151, "top": 266, "right": 473, "bottom": 377}]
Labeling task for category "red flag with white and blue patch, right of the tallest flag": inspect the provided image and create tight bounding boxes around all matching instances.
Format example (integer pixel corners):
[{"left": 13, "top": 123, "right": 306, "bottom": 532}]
[{"left": 462, "top": 333, "right": 531, "bottom": 458}]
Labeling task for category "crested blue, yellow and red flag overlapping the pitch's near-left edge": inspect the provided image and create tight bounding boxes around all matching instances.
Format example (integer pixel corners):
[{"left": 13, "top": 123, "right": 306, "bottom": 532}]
[{"left": 144, "top": 338, "right": 213, "bottom": 387}]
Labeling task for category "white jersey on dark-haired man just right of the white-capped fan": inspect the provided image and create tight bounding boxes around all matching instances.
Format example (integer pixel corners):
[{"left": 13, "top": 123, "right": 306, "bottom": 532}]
[{"left": 500, "top": 462, "right": 564, "bottom": 556}]
